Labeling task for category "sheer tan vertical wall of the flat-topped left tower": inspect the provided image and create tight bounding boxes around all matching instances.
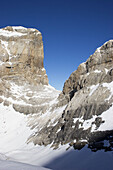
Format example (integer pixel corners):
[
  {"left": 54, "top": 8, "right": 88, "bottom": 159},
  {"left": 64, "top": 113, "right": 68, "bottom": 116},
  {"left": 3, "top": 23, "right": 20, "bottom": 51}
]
[{"left": 0, "top": 26, "right": 48, "bottom": 85}]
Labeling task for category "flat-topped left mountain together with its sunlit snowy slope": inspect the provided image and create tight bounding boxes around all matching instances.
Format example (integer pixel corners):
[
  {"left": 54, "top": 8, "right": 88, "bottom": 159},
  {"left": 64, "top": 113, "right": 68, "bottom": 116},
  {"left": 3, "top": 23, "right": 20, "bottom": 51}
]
[{"left": 0, "top": 27, "right": 65, "bottom": 169}]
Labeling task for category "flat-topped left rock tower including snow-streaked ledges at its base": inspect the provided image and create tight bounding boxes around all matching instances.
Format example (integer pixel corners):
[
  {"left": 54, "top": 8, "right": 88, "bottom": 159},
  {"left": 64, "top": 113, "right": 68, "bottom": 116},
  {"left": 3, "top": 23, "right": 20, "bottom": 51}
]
[{"left": 0, "top": 26, "right": 55, "bottom": 121}]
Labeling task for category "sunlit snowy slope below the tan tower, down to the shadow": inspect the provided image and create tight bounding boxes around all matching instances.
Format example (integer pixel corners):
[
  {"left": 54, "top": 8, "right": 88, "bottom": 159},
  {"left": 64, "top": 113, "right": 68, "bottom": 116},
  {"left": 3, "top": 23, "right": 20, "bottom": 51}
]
[{"left": 0, "top": 80, "right": 67, "bottom": 170}]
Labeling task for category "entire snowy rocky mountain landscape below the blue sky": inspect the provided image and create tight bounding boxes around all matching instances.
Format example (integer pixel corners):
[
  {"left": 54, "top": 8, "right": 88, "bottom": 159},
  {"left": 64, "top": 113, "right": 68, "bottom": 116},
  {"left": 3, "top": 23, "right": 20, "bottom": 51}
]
[{"left": 0, "top": 26, "right": 113, "bottom": 170}]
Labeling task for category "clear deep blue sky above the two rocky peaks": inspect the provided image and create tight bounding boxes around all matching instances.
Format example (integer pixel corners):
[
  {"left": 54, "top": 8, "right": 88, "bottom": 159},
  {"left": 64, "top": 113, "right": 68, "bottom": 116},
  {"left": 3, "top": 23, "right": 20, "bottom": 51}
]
[{"left": 0, "top": 0, "right": 113, "bottom": 90}]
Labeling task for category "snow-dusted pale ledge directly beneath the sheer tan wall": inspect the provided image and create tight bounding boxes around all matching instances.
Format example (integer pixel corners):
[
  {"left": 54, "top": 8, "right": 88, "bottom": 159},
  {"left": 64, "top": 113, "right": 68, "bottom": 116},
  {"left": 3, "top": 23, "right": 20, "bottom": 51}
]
[{"left": 1, "top": 82, "right": 60, "bottom": 106}]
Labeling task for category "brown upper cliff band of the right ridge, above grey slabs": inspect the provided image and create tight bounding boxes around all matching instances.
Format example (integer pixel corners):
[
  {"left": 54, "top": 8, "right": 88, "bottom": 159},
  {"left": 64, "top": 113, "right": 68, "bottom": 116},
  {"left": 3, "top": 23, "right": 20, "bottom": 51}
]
[{"left": 63, "top": 40, "right": 113, "bottom": 97}]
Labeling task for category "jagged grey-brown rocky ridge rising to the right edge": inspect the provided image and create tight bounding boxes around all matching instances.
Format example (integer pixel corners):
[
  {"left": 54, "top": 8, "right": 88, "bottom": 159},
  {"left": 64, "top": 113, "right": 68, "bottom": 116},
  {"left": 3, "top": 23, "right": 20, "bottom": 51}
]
[{"left": 35, "top": 40, "right": 113, "bottom": 149}]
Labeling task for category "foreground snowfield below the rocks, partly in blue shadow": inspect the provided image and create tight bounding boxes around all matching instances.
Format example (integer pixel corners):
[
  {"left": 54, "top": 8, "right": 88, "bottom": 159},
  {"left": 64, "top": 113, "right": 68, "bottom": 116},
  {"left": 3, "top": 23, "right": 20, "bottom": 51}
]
[{"left": 0, "top": 107, "right": 113, "bottom": 170}]
